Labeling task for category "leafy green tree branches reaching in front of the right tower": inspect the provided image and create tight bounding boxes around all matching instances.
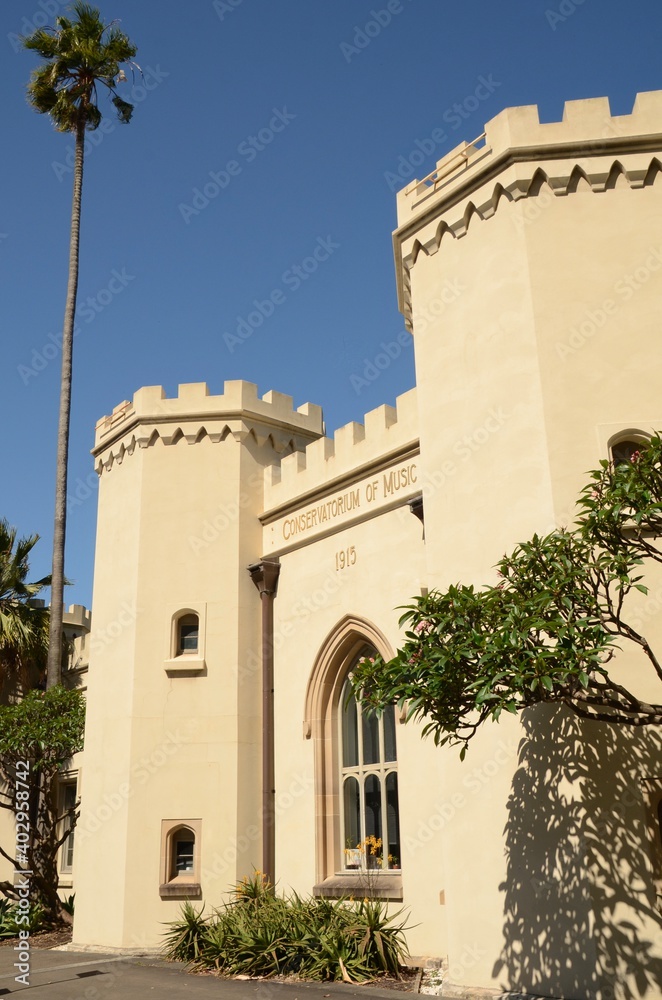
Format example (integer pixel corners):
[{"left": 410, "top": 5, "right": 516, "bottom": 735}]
[{"left": 353, "top": 435, "right": 662, "bottom": 757}]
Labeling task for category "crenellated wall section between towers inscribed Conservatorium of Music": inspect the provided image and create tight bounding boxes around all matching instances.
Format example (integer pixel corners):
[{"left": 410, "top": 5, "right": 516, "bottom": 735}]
[{"left": 261, "top": 389, "right": 421, "bottom": 550}]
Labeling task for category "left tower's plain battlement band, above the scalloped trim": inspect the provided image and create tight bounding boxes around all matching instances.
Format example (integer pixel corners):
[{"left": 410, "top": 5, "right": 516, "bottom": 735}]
[{"left": 92, "top": 380, "right": 324, "bottom": 456}]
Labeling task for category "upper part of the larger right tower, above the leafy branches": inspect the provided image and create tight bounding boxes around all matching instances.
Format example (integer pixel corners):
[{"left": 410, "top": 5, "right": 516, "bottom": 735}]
[{"left": 394, "top": 92, "right": 662, "bottom": 585}]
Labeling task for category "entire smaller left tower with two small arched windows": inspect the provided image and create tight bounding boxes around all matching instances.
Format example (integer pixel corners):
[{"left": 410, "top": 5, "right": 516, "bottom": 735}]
[{"left": 76, "top": 382, "right": 322, "bottom": 949}]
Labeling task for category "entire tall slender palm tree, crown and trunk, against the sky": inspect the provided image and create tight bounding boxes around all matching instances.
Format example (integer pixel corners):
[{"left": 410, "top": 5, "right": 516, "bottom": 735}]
[{"left": 23, "top": 0, "right": 137, "bottom": 688}]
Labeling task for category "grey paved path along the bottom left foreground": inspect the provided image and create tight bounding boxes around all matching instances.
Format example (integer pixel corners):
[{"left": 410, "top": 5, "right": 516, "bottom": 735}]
[{"left": 0, "top": 947, "right": 406, "bottom": 1000}]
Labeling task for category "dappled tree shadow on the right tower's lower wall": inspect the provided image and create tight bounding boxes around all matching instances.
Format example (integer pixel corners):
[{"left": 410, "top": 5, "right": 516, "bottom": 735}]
[{"left": 493, "top": 706, "right": 662, "bottom": 1000}]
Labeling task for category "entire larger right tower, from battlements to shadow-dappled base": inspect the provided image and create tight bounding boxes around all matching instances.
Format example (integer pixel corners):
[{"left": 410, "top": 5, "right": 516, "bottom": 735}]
[{"left": 394, "top": 92, "right": 662, "bottom": 997}]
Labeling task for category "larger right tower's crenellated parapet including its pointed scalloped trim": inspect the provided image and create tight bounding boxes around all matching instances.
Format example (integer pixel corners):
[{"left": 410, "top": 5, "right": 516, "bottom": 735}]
[{"left": 393, "top": 91, "right": 662, "bottom": 329}]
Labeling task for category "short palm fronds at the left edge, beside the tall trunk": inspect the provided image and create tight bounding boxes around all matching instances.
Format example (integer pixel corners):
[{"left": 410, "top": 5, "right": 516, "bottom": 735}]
[{"left": 0, "top": 519, "right": 50, "bottom": 702}]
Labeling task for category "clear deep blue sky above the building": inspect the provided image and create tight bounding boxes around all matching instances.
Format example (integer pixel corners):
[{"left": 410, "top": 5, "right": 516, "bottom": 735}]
[{"left": 0, "top": 0, "right": 662, "bottom": 605}]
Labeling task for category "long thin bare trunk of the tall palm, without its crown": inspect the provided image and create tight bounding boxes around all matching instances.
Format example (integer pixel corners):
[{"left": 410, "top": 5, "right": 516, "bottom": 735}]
[{"left": 46, "top": 114, "right": 85, "bottom": 688}]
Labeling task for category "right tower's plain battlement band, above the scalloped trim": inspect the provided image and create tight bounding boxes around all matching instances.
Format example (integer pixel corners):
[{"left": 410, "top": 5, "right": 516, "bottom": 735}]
[{"left": 397, "top": 90, "right": 662, "bottom": 229}]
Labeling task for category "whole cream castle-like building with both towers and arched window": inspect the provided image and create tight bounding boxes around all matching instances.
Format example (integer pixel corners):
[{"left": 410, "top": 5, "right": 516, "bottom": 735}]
[{"left": 62, "top": 93, "right": 662, "bottom": 1000}]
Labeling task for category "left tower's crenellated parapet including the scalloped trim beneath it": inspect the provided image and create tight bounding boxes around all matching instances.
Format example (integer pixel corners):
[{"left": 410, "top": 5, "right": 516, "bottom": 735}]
[{"left": 92, "top": 380, "right": 323, "bottom": 473}]
